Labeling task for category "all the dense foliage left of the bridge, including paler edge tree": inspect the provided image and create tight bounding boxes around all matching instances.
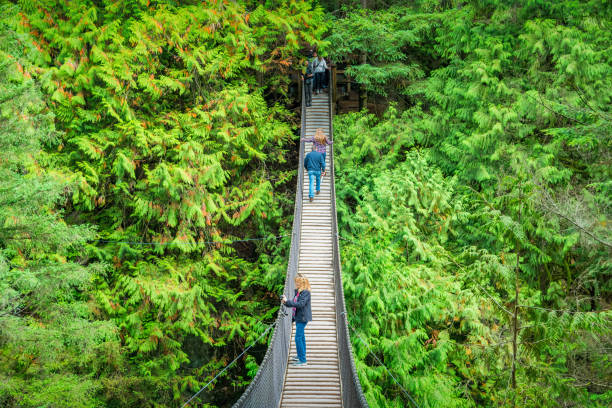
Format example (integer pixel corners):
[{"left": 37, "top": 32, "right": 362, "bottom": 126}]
[{"left": 0, "top": 0, "right": 323, "bottom": 407}]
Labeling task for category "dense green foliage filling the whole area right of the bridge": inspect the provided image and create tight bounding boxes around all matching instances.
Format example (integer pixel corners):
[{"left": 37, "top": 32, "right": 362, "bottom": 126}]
[{"left": 327, "top": 1, "right": 612, "bottom": 407}]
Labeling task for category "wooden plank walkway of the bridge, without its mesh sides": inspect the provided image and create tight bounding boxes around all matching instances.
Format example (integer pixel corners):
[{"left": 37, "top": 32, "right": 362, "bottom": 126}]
[{"left": 281, "top": 93, "right": 342, "bottom": 408}]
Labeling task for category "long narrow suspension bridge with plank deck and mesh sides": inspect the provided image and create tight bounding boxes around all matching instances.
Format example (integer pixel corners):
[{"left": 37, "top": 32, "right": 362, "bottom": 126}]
[{"left": 234, "top": 89, "right": 368, "bottom": 408}]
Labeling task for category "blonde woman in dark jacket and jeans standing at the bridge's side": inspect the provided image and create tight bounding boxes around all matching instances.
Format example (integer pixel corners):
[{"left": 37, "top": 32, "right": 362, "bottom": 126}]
[{"left": 282, "top": 274, "right": 312, "bottom": 367}]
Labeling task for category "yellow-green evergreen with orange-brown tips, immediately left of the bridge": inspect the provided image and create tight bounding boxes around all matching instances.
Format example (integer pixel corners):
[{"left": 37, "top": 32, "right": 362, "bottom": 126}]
[{"left": 8, "top": 0, "right": 324, "bottom": 406}]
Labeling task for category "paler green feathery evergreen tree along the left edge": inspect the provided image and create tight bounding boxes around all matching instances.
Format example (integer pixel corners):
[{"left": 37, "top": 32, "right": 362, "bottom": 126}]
[{"left": 0, "top": 6, "right": 122, "bottom": 407}]
